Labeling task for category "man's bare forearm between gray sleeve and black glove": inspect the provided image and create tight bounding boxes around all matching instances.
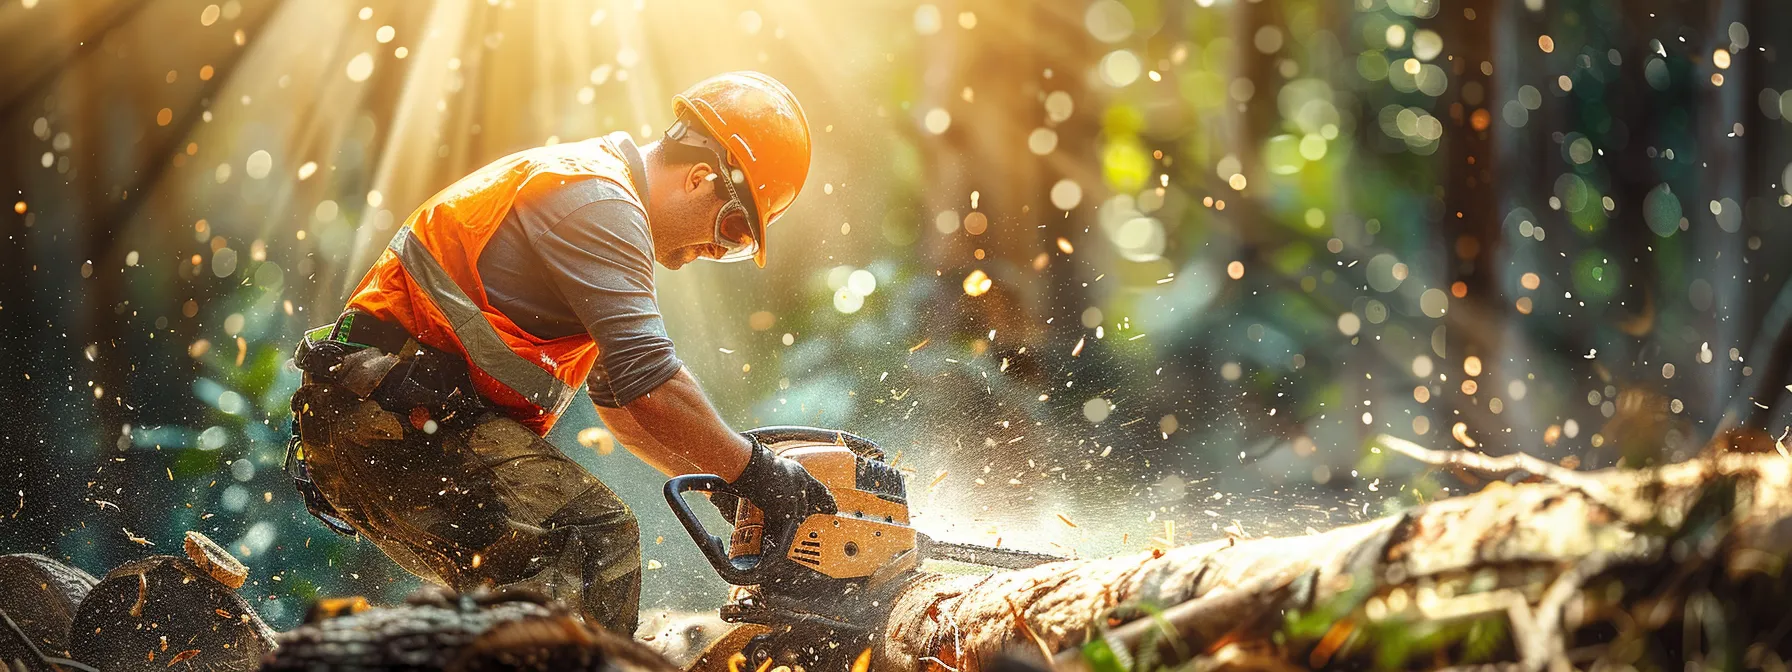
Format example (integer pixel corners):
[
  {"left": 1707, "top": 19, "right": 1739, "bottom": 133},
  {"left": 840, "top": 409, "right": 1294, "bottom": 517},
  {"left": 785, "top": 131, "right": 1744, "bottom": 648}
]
[{"left": 597, "top": 367, "right": 753, "bottom": 482}]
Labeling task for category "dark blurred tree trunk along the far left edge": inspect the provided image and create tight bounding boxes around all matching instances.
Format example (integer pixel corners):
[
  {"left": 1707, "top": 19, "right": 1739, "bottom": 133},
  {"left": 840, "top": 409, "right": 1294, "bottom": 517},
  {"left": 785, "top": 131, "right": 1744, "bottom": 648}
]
[{"left": 0, "top": 2, "right": 147, "bottom": 559}]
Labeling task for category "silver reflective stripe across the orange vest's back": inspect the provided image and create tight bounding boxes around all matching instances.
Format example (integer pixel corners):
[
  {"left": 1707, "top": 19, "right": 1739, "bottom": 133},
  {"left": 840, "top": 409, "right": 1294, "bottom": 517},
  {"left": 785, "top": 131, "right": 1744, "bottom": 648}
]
[{"left": 387, "top": 226, "right": 577, "bottom": 416}]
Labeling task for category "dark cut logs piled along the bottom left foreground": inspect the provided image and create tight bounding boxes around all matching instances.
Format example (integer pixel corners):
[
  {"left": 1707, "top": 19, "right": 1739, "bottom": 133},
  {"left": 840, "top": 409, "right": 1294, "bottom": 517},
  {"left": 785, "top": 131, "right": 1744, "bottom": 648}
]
[{"left": 0, "top": 532, "right": 676, "bottom": 672}]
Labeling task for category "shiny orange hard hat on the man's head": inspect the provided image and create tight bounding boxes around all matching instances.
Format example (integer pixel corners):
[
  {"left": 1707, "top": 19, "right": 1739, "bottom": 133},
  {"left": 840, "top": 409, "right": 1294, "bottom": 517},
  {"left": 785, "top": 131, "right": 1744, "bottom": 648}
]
[{"left": 672, "top": 70, "right": 810, "bottom": 269}]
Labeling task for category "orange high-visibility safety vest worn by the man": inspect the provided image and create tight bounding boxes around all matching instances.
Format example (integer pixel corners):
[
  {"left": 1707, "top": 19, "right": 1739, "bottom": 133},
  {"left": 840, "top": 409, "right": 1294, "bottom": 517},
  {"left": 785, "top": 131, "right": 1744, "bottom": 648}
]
[{"left": 348, "top": 138, "right": 645, "bottom": 434}]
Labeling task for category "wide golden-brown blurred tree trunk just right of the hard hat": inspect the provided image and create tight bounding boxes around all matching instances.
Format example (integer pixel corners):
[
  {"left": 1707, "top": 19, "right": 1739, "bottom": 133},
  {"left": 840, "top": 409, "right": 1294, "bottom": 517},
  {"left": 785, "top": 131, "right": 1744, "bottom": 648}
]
[{"left": 910, "top": 0, "right": 1118, "bottom": 473}]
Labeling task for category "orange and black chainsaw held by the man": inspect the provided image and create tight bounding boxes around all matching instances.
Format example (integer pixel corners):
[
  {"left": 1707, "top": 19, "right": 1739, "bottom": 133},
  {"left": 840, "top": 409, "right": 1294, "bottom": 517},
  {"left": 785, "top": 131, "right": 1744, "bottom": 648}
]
[{"left": 665, "top": 426, "right": 1063, "bottom": 670}]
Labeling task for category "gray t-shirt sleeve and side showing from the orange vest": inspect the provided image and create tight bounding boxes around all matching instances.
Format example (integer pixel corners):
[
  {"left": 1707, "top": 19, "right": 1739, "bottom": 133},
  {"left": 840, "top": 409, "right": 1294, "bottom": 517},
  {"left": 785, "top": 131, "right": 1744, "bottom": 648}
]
[{"left": 478, "top": 171, "right": 685, "bottom": 409}]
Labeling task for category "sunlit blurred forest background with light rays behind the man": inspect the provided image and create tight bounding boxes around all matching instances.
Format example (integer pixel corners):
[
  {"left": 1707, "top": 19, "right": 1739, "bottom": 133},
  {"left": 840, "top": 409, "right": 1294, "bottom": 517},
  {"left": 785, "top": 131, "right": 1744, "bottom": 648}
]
[{"left": 0, "top": 0, "right": 1792, "bottom": 629}]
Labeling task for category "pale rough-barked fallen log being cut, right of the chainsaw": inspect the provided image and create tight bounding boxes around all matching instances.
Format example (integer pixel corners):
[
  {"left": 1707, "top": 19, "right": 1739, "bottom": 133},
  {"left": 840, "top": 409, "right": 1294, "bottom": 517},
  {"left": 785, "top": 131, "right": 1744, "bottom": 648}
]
[{"left": 874, "top": 448, "right": 1792, "bottom": 672}]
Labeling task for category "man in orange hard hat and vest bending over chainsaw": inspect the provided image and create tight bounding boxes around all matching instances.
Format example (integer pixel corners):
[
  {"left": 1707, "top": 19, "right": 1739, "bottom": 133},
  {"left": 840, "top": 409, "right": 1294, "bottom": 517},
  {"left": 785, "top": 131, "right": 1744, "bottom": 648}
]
[{"left": 292, "top": 72, "right": 833, "bottom": 634}]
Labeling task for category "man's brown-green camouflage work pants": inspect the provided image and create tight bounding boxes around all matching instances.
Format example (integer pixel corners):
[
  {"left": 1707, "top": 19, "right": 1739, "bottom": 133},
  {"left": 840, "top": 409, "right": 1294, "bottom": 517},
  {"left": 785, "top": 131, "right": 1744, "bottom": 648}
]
[{"left": 292, "top": 375, "right": 642, "bottom": 636}]
